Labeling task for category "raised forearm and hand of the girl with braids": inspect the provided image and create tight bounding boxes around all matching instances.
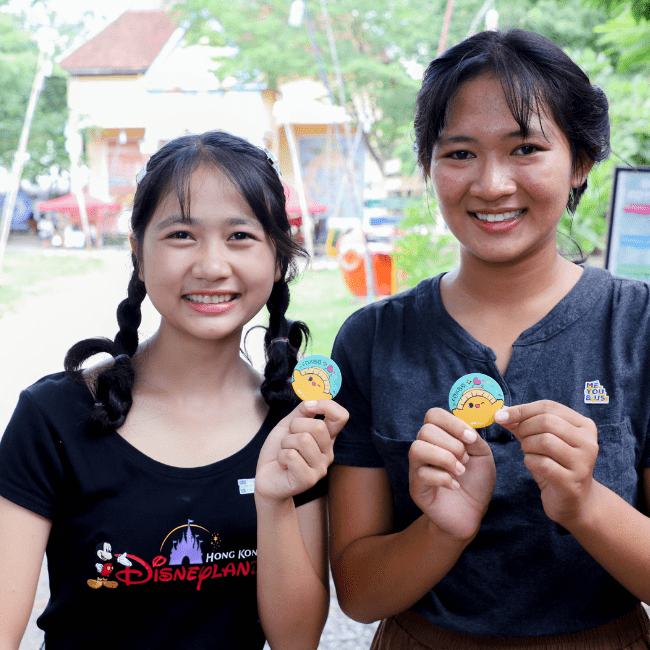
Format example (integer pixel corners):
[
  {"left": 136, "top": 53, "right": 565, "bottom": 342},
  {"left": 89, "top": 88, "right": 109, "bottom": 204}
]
[{"left": 255, "top": 400, "right": 347, "bottom": 650}]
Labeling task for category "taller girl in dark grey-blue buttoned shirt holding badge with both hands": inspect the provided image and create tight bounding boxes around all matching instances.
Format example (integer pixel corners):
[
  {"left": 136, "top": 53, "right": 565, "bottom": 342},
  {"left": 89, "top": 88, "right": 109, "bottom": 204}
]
[{"left": 329, "top": 30, "right": 650, "bottom": 650}]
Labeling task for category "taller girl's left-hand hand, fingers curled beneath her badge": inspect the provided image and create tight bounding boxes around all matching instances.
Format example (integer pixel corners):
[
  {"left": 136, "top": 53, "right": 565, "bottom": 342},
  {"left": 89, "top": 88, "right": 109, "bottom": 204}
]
[{"left": 409, "top": 408, "right": 496, "bottom": 540}]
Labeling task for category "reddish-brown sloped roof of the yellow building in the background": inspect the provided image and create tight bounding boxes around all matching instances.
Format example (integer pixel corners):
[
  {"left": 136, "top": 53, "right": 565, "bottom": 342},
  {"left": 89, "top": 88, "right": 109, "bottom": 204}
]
[{"left": 60, "top": 11, "right": 177, "bottom": 76}]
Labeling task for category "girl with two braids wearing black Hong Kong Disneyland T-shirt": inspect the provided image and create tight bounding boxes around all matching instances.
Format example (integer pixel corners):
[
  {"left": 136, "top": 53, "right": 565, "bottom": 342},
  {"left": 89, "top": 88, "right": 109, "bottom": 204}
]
[{"left": 0, "top": 132, "right": 347, "bottom": 650}]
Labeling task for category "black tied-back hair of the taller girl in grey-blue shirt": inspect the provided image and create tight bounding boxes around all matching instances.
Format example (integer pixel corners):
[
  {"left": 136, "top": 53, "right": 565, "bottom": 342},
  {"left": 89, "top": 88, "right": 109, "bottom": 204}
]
[{"left": 415, "top": 29, "right": 610, "bottom": 212}]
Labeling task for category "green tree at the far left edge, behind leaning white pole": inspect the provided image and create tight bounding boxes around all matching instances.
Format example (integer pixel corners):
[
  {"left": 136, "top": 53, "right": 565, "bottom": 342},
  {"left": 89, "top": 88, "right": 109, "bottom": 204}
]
[{"left": 0, "top": 13, "right": 68, "bottom": 180}]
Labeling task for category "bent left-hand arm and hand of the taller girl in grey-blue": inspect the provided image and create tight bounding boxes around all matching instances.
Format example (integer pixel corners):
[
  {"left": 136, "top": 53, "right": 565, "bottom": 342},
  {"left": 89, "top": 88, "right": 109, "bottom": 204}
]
[{"left": 329, "top": 409, "right": 496, "bottom": 623}]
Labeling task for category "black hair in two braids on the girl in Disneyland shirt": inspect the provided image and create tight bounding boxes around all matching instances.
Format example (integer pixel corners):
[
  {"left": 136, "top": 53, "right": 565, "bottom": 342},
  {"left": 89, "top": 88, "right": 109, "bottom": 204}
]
[{"left": 65, "top": 131, "right": 309, "bottom": 431}]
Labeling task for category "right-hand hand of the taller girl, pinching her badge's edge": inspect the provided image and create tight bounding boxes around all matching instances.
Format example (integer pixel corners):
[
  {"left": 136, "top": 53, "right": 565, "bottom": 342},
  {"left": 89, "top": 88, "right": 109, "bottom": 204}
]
[{"left": 494, "top": 400, "right": 598, "bottom": 529}]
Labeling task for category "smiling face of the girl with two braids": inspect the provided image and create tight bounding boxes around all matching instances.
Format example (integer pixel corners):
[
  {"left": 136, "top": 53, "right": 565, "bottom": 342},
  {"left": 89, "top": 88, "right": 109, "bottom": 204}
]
[{"left": 136, "top": 165, "right": 280, "bottom": 343}]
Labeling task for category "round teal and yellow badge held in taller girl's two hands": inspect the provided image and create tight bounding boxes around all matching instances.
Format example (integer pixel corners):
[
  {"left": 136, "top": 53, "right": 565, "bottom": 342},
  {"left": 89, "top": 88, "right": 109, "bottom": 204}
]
[{"left": 449, "top": 373, "right": 503, "bottom": 429}]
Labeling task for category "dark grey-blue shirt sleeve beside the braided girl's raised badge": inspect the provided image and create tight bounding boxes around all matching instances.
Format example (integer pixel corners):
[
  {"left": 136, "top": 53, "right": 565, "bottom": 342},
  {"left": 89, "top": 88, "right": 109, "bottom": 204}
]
[{"left": 332, "top": 309, "right": 384, "bottom": 467}]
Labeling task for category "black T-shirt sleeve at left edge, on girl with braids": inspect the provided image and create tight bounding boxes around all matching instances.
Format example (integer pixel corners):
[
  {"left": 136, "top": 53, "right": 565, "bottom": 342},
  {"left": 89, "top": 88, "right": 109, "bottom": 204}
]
[{"left": 0, "top": 384, "right": 64, "bottom": 519}]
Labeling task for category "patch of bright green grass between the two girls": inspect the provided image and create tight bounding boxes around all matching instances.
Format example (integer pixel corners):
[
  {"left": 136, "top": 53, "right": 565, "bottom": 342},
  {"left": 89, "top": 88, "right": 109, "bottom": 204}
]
[{"left": 287, "top": 269, "right": 366, "bottom": 357}]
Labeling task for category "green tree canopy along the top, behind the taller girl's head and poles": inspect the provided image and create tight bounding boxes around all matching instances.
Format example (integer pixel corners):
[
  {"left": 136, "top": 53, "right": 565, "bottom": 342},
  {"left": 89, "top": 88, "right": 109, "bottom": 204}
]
[{"left": 177, "top": 0, "right": 606, "bottom": 174}]
